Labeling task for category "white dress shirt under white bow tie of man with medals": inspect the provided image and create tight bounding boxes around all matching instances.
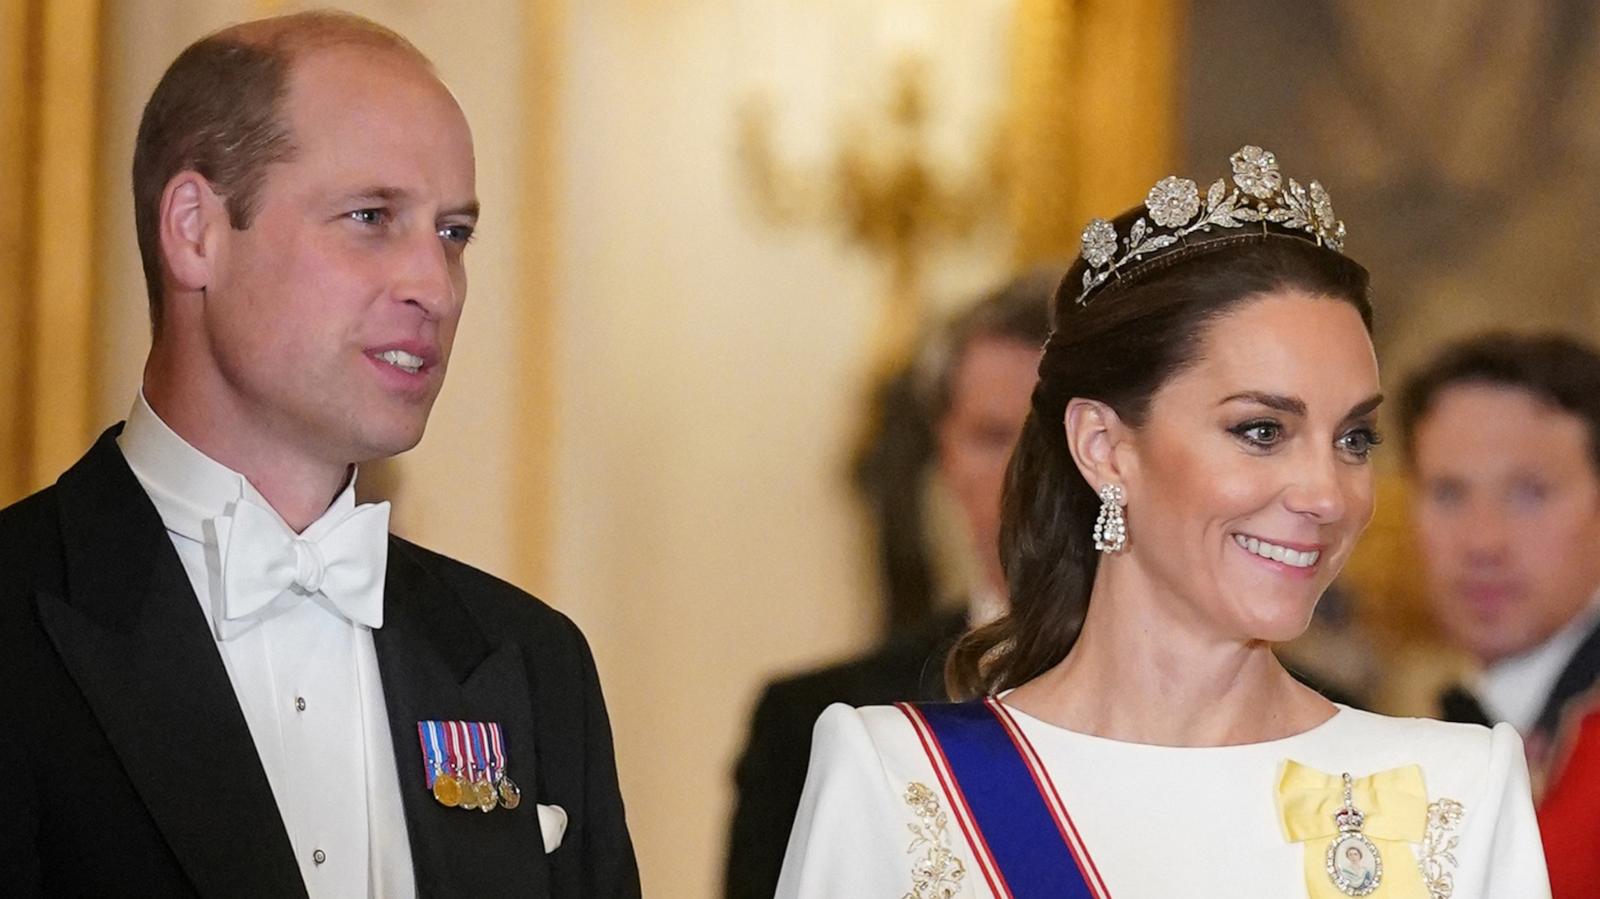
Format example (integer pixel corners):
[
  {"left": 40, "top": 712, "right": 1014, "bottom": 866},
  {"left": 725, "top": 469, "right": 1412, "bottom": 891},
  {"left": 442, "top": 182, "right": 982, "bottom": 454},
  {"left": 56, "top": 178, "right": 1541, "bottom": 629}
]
[{"left": 117, "top": 392, "right": 422, "bottom": 899}]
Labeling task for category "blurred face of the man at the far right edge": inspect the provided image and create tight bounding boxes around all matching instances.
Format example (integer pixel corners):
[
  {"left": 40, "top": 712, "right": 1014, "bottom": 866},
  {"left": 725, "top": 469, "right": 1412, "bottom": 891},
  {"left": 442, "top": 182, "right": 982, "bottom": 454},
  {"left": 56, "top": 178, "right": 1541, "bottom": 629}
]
[{"left": 1414, "top": 384, "right": 1600, "bottom": 664}]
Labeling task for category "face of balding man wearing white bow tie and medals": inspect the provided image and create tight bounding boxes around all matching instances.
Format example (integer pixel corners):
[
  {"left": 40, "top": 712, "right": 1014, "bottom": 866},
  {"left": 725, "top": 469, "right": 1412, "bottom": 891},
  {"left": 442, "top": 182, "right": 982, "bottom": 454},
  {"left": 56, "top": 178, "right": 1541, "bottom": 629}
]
[{"left": 205, "top": 46, "right": 477, "bottom": 464}]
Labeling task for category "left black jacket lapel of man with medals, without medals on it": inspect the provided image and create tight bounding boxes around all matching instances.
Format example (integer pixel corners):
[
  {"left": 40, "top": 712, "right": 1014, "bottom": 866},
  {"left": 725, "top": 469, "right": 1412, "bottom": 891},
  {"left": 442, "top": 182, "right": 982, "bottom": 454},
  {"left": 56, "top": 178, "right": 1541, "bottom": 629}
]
[{"left": 38, "top": 429, "right": 306, "bottom": 896}]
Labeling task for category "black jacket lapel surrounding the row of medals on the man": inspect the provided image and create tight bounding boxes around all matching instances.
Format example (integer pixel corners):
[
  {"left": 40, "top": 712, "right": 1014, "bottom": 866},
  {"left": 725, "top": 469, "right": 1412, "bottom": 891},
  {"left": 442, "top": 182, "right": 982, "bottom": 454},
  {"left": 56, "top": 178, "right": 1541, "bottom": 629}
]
[{"left": 373, "top": 539, "right": 550, "bottom": 896}]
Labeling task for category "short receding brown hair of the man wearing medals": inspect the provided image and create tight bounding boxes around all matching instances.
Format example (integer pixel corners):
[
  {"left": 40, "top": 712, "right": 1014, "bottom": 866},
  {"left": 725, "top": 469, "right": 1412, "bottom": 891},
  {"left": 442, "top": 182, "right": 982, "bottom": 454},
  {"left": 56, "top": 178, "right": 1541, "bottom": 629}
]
[{"left": 133, "top": 11, "right": 432, "bottom": 331}]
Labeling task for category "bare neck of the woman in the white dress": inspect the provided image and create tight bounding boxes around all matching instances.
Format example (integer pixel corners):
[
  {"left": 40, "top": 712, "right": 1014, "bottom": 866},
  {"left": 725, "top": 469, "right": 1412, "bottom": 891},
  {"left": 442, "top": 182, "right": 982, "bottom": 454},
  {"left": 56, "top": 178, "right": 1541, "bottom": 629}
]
[{"left": 1006, "top": 559, "right": 1334, "bottom": 745}]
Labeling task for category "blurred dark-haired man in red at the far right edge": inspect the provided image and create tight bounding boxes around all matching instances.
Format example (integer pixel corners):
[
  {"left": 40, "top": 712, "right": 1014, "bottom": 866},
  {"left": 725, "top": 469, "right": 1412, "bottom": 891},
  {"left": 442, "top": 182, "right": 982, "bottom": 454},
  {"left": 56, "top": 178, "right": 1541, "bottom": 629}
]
[{"left": 1400, "top": 334, "right": 1600, "bottom": 899}]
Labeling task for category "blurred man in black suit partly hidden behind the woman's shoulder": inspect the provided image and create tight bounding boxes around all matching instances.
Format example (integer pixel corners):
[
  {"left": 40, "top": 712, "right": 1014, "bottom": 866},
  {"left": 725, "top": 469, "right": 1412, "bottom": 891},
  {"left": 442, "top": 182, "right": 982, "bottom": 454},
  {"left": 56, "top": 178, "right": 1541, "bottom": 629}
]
[{"left": 723, "top": 270, "right": 1059, "bottom": 899}]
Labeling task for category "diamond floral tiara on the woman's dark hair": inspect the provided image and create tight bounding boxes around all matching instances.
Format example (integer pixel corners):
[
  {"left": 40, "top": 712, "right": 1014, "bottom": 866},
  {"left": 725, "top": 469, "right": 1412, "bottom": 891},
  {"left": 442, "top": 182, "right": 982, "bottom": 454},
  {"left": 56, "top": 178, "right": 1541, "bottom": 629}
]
[{"left": 1077, "top": 146, "right": 1344, "bottom": 306}]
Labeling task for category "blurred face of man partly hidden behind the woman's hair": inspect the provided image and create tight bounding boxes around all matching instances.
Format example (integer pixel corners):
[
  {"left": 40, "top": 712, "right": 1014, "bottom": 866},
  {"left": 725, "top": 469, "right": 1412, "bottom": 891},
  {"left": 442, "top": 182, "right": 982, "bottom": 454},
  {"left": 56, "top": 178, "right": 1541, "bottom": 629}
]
[{"left": 938, "top": 338, "right": 1038, "bottom": 589}]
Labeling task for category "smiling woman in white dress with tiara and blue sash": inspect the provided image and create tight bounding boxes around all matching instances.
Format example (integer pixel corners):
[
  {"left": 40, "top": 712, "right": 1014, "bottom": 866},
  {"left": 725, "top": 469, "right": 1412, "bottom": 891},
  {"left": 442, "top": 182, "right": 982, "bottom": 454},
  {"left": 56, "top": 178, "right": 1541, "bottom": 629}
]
[{"left": 778, "top": 147, "right": 1549, "bottom": 899}]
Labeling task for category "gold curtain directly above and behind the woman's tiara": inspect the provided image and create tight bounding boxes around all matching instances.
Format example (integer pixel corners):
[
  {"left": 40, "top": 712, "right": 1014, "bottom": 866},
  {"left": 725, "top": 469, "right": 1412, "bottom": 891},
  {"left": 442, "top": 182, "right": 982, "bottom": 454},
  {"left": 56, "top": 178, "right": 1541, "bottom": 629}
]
[{"left": 1010, "top": 0, "right": 1186, "bottom": 264}]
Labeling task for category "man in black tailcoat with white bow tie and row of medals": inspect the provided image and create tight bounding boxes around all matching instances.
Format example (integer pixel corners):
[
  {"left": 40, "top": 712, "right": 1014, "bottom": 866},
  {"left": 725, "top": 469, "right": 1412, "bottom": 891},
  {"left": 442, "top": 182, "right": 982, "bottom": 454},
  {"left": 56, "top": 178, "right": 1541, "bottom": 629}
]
[{"left": 0, "top": 13, "right": 640, "bottom": 897}]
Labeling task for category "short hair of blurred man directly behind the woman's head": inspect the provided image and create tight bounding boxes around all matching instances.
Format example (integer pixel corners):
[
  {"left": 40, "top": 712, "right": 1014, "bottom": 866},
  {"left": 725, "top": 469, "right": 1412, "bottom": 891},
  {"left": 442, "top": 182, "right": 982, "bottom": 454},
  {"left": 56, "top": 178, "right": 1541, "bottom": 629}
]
[{"left": 923, "top": 267, "right": 1066, "bottom": 424}]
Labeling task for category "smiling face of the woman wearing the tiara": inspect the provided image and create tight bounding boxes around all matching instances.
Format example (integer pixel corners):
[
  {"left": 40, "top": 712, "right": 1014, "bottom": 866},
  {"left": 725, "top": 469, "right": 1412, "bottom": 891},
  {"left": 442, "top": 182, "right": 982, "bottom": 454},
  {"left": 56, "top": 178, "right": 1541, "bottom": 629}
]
[{"left": 1117, "top": 291, "right": 1379, "bottom": 641}]
